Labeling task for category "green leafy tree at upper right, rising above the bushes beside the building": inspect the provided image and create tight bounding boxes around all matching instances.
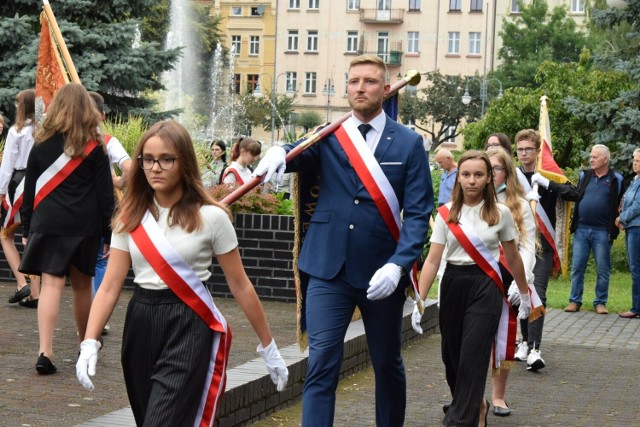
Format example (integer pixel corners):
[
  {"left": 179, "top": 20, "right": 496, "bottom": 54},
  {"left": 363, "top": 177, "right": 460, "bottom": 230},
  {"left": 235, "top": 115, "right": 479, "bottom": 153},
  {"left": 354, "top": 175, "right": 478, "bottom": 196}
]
[{"left": 495, "top": 0, "right": 587, "bottom": 87}]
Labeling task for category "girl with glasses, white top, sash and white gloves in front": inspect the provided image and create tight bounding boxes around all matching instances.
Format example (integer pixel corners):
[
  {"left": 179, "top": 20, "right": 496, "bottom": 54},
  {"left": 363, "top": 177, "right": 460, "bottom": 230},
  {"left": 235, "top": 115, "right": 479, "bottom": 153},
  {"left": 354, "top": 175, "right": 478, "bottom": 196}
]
[{"left": 76, "top": 121, "right": 288, "bottom": 426}]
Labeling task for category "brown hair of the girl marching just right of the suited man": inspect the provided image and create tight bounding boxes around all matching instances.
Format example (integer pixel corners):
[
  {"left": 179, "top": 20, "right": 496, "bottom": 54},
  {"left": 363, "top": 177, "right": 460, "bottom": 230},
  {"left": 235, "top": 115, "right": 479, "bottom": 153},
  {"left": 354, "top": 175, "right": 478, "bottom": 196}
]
[{"left": 448, "top": 150, "right": 500, "bottom": 225}]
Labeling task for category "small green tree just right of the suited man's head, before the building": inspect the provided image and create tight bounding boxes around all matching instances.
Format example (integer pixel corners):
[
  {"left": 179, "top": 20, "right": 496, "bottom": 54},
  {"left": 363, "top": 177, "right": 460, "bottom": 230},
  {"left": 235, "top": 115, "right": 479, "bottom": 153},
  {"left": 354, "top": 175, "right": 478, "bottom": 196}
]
[{"left": 398, "top": 70, "right": 480, "bottom": 149}]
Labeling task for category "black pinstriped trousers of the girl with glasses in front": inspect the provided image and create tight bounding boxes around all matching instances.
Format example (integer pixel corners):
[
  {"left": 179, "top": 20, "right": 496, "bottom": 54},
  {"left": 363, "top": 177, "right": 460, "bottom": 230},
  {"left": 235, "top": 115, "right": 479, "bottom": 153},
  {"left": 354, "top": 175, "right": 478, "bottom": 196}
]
[{"left": 122, "top": 286, "right": 214, "bottom": 426}]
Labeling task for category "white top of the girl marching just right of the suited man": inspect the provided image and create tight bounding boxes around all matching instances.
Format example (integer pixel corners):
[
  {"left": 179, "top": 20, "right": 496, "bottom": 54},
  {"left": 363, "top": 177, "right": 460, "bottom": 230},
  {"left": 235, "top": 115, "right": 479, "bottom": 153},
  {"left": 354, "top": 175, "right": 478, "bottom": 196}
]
[{"left": 429, "top": 201, "right": 518, "bottom": 265}]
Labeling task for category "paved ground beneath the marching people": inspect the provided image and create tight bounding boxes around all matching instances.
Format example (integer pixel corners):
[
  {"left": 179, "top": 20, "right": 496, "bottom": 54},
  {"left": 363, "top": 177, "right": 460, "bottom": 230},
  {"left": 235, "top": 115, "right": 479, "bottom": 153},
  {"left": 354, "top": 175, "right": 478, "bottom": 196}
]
[{"left": 0, "top": 284, "right": 640, "bottom": 427}]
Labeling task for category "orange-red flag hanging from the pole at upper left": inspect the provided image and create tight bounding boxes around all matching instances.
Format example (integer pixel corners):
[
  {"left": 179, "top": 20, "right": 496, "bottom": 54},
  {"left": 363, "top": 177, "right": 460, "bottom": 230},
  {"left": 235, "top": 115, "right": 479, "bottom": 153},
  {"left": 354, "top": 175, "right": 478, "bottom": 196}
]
[{"left": 36, "top": 12, "right": 69, "bottom": 118}]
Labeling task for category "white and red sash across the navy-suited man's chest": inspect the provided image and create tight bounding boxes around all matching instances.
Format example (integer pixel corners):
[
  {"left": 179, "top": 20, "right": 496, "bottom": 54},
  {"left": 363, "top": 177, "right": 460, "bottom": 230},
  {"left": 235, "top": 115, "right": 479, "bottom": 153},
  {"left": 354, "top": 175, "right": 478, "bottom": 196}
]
[{"left": 335, "top": 120, "right": 422, "bottom": 305}]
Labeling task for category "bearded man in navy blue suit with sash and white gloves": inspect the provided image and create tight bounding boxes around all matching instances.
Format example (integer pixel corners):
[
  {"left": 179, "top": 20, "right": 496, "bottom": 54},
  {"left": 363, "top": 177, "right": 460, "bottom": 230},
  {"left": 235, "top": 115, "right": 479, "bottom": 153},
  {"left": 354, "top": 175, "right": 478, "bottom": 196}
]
[{"left": 255, "top": 55, "right": 433, "bottom": 426}]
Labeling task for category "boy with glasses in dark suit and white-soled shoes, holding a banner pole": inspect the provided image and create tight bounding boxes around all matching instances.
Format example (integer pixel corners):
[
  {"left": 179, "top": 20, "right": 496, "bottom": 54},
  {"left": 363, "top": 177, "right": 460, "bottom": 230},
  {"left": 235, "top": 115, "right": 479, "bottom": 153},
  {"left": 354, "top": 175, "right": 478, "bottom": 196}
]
[{"left": 515, "top": 129, "right": 578, "bottom": 371}]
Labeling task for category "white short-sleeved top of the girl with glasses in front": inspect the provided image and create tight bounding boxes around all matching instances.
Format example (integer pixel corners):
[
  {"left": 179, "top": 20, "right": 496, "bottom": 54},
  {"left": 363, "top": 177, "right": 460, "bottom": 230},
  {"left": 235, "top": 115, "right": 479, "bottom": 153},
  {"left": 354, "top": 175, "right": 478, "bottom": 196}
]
[{"left": 111, "top": 203, "right": 238, "bottom": 290}]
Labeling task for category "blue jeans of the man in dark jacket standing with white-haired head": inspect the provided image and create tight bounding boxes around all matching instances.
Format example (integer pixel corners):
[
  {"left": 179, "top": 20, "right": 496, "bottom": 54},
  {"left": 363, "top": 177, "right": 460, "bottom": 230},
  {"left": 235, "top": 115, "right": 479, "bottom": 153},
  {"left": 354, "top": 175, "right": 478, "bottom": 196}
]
[{"left": 569, "top": 227, "right": 611, "bottom": 307}]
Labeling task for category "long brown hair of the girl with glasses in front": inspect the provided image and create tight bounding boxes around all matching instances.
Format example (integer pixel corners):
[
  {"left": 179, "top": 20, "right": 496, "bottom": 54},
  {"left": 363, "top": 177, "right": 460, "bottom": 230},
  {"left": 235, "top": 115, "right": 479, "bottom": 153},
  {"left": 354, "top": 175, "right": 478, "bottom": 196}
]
[{"left": 112, "top": 120, "right": 231, "bottom": 233}]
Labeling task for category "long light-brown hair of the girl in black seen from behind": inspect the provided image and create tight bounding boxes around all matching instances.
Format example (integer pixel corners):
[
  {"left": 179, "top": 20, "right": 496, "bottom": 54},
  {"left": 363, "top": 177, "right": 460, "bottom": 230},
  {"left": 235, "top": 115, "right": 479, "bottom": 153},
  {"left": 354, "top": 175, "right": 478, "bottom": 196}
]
[{"left": 35, "top": 83, "right": 104, "bottom": 157}]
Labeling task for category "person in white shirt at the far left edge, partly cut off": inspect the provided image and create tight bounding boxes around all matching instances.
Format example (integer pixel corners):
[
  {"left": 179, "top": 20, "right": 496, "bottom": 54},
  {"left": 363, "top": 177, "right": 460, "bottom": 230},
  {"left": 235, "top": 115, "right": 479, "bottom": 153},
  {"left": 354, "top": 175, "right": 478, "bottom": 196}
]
[{"left": 0, "top": 89, "right": 40, "bottom": 308}]
